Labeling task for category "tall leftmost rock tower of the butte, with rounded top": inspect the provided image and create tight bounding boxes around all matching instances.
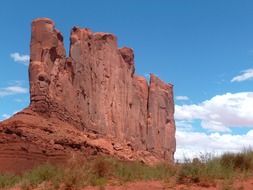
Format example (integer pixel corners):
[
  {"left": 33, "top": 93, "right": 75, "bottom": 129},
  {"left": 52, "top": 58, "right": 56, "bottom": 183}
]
[{"left": 29, "top": 18, "right": 65, "bottom": 113}]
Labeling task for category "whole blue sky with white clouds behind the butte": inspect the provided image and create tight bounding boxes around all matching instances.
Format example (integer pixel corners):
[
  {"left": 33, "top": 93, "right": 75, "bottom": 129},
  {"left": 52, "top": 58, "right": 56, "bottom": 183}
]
[{"left": 0, "top": 0, "right": 253, "bottom": 158}]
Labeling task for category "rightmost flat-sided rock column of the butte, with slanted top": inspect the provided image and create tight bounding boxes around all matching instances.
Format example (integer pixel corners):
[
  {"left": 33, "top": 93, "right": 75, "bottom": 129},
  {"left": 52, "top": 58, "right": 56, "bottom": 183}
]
[{"left": 147, "top": 74, "right": 176, "bottom": 161}]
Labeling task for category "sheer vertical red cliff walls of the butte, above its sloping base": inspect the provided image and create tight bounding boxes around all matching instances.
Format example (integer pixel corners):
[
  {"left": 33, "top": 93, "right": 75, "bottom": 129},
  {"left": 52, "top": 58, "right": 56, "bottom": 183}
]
[{"left": 0, "top": 18, "right": 175, "bottom": 173}]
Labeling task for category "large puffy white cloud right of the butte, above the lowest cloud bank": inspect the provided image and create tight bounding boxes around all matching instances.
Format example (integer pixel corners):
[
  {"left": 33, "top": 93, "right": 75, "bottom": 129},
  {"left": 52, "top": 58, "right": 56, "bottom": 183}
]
[{"left": 175, "top": 92, "right": 253, "bottom": 132}]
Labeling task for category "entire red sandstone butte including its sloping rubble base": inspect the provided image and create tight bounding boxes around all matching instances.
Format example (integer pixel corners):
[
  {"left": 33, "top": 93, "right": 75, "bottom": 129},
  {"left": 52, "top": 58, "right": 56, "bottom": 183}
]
[{"left": 0, "top": 18, "right": 175, "bottom": 172}]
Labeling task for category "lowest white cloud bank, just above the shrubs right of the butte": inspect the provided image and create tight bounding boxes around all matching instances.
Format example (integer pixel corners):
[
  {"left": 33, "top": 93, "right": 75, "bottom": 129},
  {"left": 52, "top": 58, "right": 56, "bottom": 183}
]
[{"left": 175, "top": 129, "right": 253, "bottom": 161}]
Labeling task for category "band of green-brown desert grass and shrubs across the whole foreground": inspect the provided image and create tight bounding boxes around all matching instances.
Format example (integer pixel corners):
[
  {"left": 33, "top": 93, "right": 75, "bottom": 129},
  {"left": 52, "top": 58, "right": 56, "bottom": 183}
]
[{"left": 0, "top": 150, "right": 253, "bottom": 190}]
